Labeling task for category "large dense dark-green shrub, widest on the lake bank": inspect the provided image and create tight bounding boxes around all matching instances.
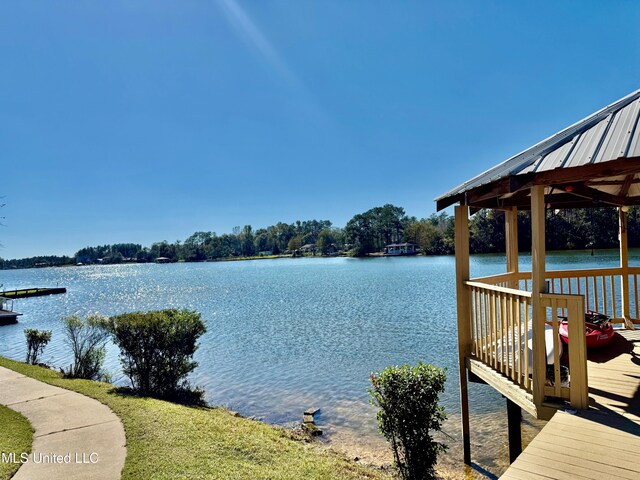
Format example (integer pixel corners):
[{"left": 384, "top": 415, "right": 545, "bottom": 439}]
[{"left": 108, "top": 309, "right": 206, "bottom": 403}]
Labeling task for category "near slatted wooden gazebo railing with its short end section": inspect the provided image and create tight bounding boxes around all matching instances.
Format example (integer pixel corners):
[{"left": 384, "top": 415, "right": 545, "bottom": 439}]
[{"left": 466, "top": 280, "right": 588, "bottom": 408}]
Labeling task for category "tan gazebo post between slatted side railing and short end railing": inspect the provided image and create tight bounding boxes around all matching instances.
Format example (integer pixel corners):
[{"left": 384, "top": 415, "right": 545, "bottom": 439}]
[{"left": 531, "top": 185, "right": 547, "bottom": 409}]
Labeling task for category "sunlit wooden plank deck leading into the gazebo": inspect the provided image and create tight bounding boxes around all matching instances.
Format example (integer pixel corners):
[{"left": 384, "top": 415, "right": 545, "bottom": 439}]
[{"left": 500, "top": 330, "right": 640, "bottom": 480}]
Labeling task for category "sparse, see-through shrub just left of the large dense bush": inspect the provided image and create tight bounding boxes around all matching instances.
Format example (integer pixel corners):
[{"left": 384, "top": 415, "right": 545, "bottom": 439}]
[{"left": 62, "top": 315, "right": 109, "bottom": 380}]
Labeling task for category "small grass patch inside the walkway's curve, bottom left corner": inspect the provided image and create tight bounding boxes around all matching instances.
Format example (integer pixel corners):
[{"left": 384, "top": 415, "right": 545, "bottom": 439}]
[{"left": 0, "top": 405, "right": 33, "bottom": 480}]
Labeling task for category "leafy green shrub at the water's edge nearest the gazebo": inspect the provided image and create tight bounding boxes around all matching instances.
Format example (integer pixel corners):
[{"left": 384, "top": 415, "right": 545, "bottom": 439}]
[{"left": 369, "top": 362, "right": 446, "bottom": 480}]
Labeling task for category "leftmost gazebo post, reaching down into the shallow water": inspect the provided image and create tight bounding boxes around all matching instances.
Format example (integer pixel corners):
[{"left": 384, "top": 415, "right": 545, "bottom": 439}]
[{"left": 455, "top": 205, "right": 472, "bottom": 465}]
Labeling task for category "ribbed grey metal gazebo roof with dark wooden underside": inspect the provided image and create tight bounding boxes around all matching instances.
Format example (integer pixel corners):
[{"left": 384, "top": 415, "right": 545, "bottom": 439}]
[{"left": 435, "top": 90, "right": 640, "bottom": 210}]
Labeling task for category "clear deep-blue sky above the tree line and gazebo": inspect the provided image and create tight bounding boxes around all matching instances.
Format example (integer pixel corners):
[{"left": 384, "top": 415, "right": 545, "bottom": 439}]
[{"left": 0, "top": 0, "right": 640, "bottom": 258}]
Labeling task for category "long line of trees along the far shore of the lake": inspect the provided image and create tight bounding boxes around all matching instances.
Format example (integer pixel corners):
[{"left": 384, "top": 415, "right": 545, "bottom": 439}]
[{"left": 0, "top": 204, "right": 640, "bottom": 269}]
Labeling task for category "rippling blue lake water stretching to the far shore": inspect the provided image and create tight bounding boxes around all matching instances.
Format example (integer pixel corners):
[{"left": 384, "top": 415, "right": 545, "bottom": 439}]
[{"left": 0, "top": 251, "right": 640, "bottom": 473}]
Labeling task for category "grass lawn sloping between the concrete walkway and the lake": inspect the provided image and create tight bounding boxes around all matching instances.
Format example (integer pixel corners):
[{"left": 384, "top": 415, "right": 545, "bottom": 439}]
[{"left": 0, "top": 357, "right": 390, "bottom": 480}]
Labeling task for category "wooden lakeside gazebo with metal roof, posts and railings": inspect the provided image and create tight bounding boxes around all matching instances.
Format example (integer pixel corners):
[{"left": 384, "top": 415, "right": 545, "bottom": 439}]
[{"left": 436, "top": 90, "right": 640, "bottom": 468}]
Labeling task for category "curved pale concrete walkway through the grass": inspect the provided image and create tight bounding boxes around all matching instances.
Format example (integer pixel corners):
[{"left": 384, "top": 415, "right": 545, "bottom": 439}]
[{"left": 0, "top": 367, "right": 127, "bottom": 480}]
